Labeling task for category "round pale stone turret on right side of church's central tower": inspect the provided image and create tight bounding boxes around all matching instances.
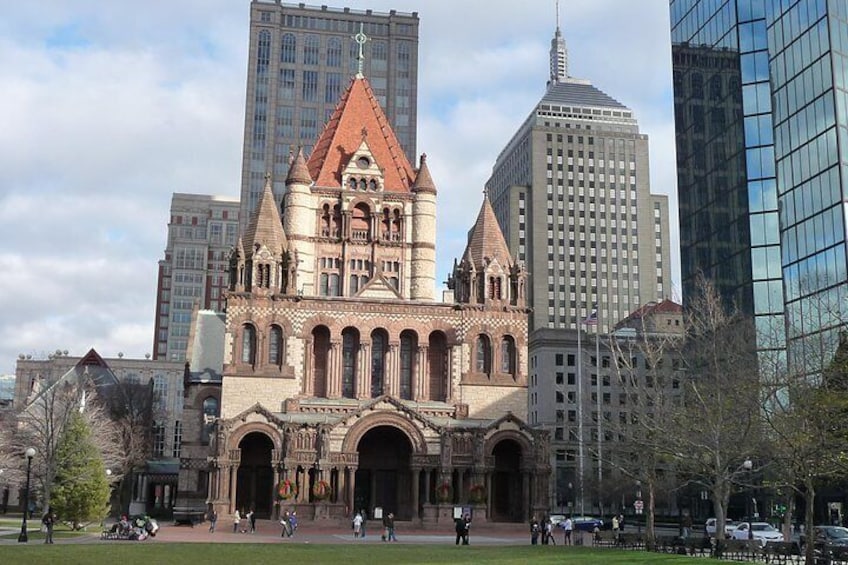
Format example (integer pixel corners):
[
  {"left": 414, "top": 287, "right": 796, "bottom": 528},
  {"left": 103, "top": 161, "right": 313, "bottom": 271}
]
[{"left": 409, "top": 155, "right": 436, "bottom": 300}]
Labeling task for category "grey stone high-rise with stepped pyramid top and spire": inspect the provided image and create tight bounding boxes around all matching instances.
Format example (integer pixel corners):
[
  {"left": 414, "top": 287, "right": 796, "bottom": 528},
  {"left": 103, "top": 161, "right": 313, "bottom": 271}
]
[{"left": 486, "top": 27, "right": 672, "bottom": 331}]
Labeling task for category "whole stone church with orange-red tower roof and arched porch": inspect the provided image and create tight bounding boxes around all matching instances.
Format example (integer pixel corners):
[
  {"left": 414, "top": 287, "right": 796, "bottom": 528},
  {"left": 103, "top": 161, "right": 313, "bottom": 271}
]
[{"left": 178, "top": 75, "right": 550, "bottom": 526}]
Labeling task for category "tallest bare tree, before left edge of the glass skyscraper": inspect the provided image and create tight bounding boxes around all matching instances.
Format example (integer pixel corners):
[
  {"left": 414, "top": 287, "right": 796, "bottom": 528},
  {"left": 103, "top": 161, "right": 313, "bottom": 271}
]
[{"left": 663, "top": 277, "right": 762, "bottom": 539}]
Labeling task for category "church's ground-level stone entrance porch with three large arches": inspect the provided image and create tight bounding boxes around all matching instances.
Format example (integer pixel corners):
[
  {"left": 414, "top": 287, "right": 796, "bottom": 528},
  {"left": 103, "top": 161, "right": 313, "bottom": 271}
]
[{"left": 210, "top": 406, "right": 549, "bottom": 525}]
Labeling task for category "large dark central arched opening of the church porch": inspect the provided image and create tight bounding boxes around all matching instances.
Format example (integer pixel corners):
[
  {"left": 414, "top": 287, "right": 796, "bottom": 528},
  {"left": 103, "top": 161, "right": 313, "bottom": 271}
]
[{"left": 354, "top": 425, "right": 413, "bottom": 520}]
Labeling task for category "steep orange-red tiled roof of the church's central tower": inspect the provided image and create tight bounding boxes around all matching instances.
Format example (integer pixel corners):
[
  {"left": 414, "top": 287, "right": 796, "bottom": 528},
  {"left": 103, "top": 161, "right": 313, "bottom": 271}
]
[{"left": 306, "top": 78, "right": 415, "bottom": 192}]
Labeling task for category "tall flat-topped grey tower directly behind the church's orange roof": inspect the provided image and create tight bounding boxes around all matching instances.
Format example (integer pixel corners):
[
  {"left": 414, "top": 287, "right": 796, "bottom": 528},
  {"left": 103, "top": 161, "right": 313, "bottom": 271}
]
[{"left": 241, "top": 0, "right": 418, "bottom": 227}]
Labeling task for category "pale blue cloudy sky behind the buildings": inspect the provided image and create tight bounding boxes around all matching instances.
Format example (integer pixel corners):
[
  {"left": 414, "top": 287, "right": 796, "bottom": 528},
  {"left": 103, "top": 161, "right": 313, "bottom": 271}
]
[{"left": 0, "top": 0, "right": 680, "bottom": 373}]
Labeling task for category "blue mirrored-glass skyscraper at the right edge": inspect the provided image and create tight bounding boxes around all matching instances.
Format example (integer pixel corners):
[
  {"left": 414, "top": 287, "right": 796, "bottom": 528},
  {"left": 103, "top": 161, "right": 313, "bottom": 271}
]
[{"left": 670, "top": 0, "right": 848, "bottom": 372}]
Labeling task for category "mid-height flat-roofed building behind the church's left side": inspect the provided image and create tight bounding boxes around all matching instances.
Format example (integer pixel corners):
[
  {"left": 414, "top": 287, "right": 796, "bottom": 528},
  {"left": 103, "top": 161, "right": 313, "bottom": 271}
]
[{"left": 153, "top": 193, "right": 239, "bottom": 361}]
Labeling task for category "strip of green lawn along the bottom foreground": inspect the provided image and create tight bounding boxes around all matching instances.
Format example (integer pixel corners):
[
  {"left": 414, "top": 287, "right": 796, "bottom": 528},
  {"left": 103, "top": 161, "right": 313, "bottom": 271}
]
[{"left": 0, "top": 541, "right": 716, "bottom": 565}]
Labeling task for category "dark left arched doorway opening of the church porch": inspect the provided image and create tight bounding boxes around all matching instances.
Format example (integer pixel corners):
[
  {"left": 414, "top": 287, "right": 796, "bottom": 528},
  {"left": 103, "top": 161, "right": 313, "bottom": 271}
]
[{"left": 236, "top": 432, "right": 274, "bottom": 518}]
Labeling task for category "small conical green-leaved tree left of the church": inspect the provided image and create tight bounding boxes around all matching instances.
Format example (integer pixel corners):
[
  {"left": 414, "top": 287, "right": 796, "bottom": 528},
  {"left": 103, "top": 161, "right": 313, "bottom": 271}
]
[{"left": 51, "top": 412, "right": 110, "bottom": 530}]
